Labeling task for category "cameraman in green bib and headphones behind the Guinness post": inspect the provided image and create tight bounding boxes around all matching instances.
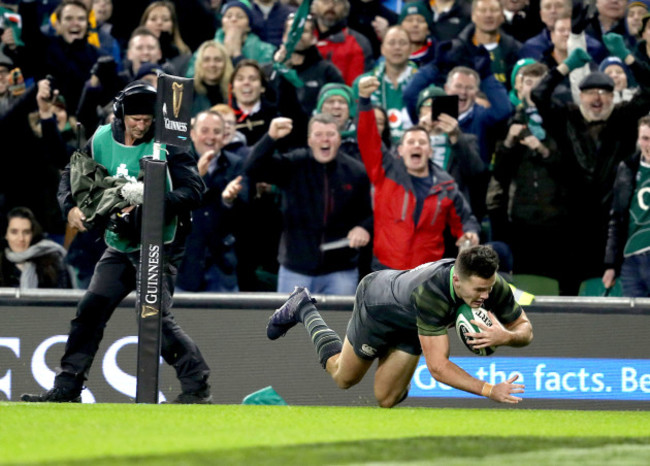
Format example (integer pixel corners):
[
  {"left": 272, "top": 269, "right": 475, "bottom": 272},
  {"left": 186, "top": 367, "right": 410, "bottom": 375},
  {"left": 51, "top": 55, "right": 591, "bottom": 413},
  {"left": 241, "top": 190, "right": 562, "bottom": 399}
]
[{"left": 22, "top": 81, "right": 212, "bottom": 404}]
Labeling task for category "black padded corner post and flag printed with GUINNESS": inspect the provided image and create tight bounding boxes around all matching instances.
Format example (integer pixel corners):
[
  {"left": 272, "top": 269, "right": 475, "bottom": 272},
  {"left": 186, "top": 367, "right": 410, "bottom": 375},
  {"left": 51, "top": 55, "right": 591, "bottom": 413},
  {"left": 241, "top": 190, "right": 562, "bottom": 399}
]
[{"left": 135, "top": 74, "right": 193, "bottom": 403}]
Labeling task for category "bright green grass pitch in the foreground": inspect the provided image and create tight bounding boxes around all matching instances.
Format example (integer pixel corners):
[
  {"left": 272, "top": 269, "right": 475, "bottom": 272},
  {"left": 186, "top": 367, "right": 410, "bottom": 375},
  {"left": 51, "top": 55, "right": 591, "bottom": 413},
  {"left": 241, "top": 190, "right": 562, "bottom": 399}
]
[{"left": 0, "top": 402, "right": 650, "bottom": 466}]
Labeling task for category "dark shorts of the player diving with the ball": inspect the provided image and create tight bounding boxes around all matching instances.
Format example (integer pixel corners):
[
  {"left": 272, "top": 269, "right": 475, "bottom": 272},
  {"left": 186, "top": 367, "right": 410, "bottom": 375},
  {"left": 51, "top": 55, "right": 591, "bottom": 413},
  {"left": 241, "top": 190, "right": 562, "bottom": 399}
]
[{"left": 346, "top": 271, "right": 422, "bottom": 361}]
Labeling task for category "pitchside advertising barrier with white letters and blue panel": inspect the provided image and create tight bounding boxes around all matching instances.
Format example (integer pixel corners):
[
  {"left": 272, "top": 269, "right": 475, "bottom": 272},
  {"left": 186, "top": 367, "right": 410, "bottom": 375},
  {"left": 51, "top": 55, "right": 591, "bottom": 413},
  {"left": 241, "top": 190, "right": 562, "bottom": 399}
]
[{"left": 0, "top": 288, "right": 650, "bottom": 410}]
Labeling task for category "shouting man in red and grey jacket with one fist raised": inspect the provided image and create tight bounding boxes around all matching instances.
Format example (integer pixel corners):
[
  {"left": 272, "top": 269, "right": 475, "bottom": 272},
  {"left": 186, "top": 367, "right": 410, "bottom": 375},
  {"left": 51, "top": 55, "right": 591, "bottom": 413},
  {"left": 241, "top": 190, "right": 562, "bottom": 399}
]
[{"left": 357, "top": 76, "right": 479, "bottom": 270}]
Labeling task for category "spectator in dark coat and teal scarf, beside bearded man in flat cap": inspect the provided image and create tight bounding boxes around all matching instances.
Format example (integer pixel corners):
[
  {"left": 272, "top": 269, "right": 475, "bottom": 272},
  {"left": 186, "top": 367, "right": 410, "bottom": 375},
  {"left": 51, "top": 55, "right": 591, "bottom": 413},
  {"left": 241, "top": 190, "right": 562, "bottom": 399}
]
[{"left": 493, "top": 63, "right": 567, "bottom": 279}]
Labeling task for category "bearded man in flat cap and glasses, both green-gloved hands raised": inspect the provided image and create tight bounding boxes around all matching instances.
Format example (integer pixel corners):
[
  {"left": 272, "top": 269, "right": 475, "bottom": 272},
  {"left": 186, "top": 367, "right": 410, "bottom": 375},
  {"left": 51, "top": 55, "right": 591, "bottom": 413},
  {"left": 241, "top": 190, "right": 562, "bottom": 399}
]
[{"left": 531, "top": 34, "right": 650, "bottom": 292}]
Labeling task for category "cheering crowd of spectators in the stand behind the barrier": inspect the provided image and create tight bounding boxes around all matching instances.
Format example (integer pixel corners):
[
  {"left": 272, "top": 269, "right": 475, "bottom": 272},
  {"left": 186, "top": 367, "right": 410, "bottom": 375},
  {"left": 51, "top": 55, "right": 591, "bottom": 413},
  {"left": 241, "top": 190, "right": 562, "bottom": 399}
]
[{"left": 0, "top": 0, "right": 650, "bottom": 296}]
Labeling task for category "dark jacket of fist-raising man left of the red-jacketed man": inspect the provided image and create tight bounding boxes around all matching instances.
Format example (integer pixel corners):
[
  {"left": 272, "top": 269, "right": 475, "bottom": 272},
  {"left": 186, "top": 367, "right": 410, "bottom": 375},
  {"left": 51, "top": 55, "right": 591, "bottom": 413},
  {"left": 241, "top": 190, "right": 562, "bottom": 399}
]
[{"left": 245, "top": 135, "right": 372, "bottom": 276}]
